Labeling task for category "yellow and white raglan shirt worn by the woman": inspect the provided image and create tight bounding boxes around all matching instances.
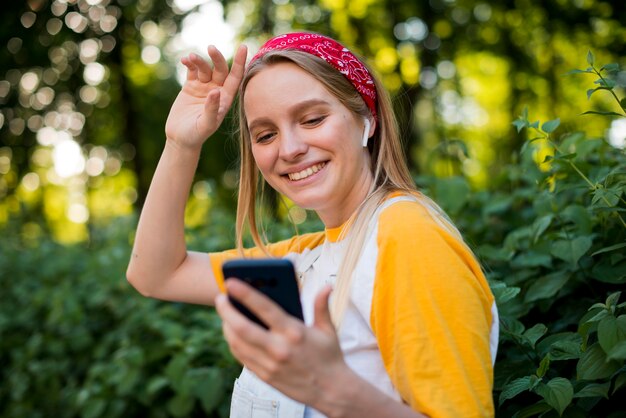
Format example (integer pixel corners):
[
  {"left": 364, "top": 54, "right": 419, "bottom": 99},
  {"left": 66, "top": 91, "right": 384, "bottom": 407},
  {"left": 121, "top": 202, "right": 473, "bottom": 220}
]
[{"left": 210, "top": 195, "right": 498, "bottom": 418}]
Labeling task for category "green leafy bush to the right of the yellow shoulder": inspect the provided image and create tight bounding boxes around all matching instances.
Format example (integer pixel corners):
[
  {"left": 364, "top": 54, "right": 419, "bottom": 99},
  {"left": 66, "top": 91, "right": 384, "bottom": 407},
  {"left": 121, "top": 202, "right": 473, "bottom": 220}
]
[{"left": 420, "top": 53, "right": 626, "bottom": 417}]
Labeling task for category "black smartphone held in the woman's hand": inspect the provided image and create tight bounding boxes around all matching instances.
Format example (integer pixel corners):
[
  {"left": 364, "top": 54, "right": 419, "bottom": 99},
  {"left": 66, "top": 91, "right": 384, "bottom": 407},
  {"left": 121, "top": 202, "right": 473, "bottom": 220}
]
[{"left": 222, "top": 258, "right": 304, "bottom": 329}]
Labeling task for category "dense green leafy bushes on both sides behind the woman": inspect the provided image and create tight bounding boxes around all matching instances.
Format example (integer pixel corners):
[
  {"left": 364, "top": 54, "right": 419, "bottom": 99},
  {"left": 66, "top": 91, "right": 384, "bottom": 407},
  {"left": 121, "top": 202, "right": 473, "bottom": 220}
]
[{"left": 0, "top": 54, "right": 626, "bottom": 418}]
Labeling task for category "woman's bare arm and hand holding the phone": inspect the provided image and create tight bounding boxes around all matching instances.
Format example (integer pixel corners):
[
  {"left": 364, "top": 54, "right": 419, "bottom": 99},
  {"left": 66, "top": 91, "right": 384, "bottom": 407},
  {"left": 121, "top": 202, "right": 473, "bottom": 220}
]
[{"left": 216, "top": 280, "right": 424, "bottom": 418}]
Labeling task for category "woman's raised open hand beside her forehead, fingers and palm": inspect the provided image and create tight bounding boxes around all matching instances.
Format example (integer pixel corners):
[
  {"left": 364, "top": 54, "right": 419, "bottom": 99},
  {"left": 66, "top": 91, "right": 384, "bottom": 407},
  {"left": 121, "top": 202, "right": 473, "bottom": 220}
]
[{"left": 165, "top": 45, "right": 247, "bottom": 148}]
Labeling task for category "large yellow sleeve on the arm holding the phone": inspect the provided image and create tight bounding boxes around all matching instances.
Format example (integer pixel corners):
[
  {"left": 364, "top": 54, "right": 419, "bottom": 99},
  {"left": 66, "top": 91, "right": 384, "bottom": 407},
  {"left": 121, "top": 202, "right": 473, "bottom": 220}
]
[{"left": 370, "top": 202, "right": 494, "bottom": 418}]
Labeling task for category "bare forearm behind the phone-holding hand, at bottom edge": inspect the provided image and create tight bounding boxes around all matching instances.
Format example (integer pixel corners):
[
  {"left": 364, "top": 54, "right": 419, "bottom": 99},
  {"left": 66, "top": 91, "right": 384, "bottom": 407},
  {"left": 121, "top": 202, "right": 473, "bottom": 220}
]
[{"left": 313, "top": 369, "right": 425, "bottom": 418}]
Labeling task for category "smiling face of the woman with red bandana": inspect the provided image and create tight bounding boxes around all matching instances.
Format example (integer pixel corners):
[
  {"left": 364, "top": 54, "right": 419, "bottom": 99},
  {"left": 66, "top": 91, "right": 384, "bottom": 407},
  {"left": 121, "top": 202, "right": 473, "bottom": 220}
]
[{"left": 243, "top": 63, "right": 374, "bottom": 227}]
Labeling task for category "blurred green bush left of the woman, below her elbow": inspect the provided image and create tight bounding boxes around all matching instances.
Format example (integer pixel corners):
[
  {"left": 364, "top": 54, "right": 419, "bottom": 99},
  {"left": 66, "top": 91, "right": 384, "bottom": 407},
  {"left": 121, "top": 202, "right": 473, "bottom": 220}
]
[{"left": 0, "top": 212, "right": 240, "bottom": 418}]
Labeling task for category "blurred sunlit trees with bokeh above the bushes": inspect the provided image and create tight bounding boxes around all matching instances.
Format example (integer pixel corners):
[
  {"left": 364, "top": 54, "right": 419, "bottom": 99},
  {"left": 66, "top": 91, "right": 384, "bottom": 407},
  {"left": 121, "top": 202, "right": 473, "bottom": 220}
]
[{"left": 0, "top": 0, "right": 626, "bottom": 242}]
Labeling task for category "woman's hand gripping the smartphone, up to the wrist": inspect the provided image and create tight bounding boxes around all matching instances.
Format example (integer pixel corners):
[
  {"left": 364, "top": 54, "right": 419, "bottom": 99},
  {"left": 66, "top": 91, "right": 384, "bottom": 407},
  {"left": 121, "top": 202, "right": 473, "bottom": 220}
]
[{"left": 215, "top": 280, "right": 352, "bottom": 407}]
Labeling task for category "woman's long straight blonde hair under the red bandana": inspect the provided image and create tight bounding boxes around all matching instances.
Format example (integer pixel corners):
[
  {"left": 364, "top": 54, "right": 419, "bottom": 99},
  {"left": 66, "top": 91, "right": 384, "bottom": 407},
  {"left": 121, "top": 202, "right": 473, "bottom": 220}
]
[{"left": 235, "top": 50, "right": 463, "bottom": 328}]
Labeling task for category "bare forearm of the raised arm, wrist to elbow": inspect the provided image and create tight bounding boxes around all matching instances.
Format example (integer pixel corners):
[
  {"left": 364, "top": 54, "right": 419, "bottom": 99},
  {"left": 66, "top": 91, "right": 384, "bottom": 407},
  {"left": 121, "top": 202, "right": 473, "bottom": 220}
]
[{"left": 127, "top": 140, "right": 200, "bottom": 296}]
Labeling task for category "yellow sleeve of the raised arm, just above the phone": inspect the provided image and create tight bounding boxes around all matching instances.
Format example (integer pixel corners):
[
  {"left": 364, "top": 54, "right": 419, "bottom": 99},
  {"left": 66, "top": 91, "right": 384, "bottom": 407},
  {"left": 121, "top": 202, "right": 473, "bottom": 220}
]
[{"left": 209, "top": 232, "right": 325, "bottom": 292}]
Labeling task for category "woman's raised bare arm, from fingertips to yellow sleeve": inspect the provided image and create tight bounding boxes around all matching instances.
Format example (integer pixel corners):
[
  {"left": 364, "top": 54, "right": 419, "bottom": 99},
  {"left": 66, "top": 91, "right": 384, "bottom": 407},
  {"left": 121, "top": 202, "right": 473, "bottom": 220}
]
[{"left": 126, "top": 46, "right": 247, "bottom": 304}]
